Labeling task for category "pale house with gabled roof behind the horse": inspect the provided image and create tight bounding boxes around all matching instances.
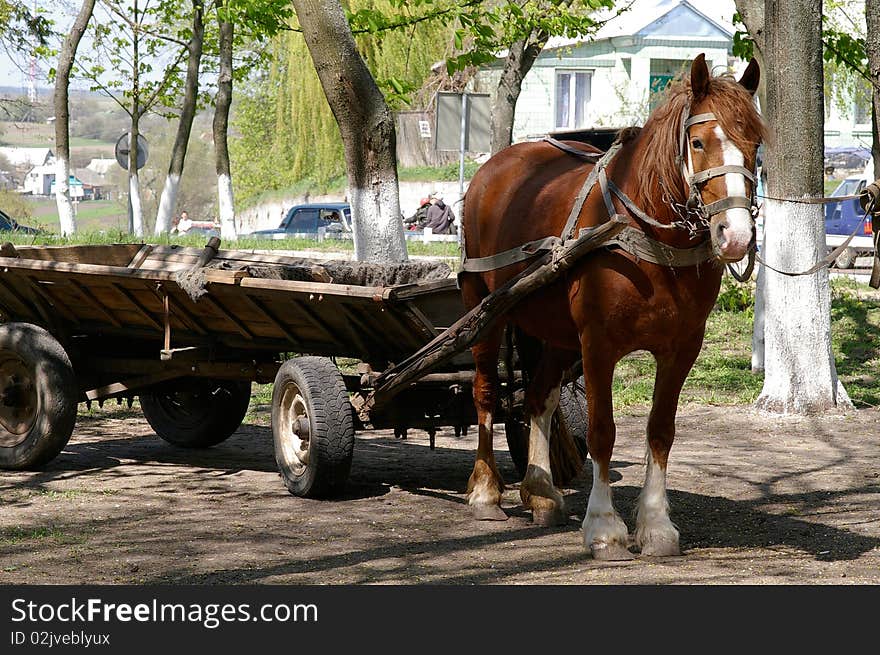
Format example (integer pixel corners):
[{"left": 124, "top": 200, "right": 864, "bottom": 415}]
[{"left": 474, "top": 0, "right": 871, "bottom": 147}]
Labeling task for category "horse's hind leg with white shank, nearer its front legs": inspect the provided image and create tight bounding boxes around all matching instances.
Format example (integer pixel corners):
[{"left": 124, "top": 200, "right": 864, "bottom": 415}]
[{"left": 519, "top": 348, "right": 575, "bottom": 526}]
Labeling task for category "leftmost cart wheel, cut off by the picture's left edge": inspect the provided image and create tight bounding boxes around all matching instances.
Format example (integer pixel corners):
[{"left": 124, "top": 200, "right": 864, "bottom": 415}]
[{"left": 0, "top": 323, "right": 78, "bottom": 469}]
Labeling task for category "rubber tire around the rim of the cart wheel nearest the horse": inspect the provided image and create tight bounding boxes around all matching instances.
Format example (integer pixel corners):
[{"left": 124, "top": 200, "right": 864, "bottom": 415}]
[{"left": 272, "top": 357, "right": 354, "bottom": 498}]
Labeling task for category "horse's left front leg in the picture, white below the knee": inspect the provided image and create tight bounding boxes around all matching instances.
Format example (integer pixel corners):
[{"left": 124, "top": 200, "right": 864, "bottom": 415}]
[{"left": 582, "top": 352, "right": 633, "bottom": 560}]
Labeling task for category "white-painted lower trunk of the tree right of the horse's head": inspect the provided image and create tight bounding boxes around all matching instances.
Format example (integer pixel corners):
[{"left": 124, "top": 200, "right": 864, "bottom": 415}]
[{"left": 757, "top": 200, "right": 852, "bottom": 414}]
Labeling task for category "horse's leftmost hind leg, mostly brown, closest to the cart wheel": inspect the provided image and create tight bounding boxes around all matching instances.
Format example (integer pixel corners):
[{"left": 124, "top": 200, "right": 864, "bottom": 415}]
[{"left": 468, "top": 325, "right": 507, "bottom": 521}]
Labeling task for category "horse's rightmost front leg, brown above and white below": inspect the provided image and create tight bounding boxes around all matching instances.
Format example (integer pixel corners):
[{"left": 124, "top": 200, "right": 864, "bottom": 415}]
[{"left": 635, "top": 339, "right": 702, "bottom": 557}]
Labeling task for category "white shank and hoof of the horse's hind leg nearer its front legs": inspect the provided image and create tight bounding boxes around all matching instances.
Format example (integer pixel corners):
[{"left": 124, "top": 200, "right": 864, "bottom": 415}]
[{"left": 519, "top": 386, "right": 567, "bottom": 525}]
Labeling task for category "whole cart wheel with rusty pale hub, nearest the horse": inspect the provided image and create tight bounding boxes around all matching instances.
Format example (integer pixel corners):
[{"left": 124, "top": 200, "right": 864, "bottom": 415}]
[{"left": 272, "top": 357, "right": 354, "bottom": 498}]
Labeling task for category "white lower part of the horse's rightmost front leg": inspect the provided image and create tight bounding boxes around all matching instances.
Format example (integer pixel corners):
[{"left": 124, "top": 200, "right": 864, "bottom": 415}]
[{"left": 635, "top": 446, "right": 679, "bottom": 556}]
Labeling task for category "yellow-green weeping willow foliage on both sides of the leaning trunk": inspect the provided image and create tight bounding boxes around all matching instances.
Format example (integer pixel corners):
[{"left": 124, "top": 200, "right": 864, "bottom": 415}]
[{"left": 230, "top": 0, "right": 450, "bottom": 201}]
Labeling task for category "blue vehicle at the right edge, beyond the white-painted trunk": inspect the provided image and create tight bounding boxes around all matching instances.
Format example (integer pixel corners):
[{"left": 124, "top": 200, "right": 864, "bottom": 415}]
[{"left": 825, "top": 161, "right": 880, "bottom": 268}]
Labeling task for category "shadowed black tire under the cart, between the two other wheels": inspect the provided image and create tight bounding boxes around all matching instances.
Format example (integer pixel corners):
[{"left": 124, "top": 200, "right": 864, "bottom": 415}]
[{"left": 140, "top": 378, "right": 251, "bottom": 448}]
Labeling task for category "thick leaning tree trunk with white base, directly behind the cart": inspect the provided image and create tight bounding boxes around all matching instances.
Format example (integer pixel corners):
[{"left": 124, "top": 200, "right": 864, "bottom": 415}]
[{"left": 293, "top": 0, "right": 407, "bottom": 262}]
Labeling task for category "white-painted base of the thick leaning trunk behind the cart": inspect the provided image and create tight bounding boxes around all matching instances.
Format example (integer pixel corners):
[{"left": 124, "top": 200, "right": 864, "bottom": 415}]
[{"left": 348, "top": 180, "right": 407, "bottom": 262}]
